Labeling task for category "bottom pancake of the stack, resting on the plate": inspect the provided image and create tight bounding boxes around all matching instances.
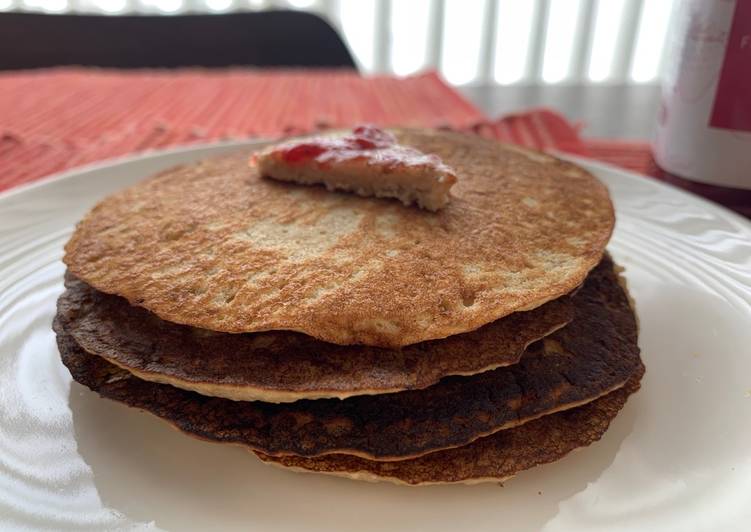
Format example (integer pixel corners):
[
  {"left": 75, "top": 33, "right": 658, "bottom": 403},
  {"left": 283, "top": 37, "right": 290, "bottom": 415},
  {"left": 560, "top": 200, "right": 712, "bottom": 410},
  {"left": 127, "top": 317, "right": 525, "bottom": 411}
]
[{"left": 255, "top": 366, "right": 644, "bottom": 486}]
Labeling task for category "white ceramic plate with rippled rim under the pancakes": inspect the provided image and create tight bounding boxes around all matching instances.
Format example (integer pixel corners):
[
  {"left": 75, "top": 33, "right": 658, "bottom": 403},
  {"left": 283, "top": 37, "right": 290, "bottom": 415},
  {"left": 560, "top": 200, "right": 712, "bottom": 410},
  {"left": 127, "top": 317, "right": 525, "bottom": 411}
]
[{"left": 0, "top": 144, "right": 751, "bottom": 532}]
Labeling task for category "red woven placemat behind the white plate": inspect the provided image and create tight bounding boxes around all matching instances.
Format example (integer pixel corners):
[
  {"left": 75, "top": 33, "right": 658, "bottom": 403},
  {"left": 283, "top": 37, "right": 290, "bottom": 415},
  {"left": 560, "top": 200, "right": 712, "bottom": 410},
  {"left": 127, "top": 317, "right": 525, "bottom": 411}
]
[{"left": 0, "top": 68, "right": 655, "bottom": 202}]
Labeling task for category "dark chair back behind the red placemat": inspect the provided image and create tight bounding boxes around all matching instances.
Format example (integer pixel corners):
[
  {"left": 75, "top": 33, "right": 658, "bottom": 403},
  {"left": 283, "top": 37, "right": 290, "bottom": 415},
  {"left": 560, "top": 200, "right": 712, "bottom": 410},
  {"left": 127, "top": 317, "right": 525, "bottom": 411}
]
[{"left": 0, "top": 11, "right": 355, "bottom": 70}]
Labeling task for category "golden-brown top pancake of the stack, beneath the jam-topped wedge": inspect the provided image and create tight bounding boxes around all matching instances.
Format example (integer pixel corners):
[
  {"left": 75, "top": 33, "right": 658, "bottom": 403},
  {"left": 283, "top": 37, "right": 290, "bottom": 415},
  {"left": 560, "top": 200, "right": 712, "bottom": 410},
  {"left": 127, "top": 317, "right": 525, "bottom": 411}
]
[{"left": 64, "top": 130, "right": 614, "bottom": 347}]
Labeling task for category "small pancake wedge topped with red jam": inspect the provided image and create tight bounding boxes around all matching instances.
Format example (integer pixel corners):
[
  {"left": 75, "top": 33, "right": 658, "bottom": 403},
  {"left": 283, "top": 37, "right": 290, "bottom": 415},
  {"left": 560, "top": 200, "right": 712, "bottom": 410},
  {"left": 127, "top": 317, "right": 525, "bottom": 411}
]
[{"left": 252, "top": 125, "right": 456, "bottom": 211}]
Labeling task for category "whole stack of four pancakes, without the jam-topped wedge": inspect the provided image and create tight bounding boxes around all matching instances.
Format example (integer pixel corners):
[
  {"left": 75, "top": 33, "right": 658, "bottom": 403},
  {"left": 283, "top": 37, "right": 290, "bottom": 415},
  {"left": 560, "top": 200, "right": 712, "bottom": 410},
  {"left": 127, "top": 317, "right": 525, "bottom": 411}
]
[{"left": 54, "top": 130, "right": 644, "bottom": 484}]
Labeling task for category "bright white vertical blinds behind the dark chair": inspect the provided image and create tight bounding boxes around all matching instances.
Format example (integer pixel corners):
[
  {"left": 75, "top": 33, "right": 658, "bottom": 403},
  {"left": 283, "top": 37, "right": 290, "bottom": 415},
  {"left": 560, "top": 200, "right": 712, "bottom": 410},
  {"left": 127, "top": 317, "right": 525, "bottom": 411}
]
[{"left": 0, "top": 0, "right": 674, "bottom": 85}]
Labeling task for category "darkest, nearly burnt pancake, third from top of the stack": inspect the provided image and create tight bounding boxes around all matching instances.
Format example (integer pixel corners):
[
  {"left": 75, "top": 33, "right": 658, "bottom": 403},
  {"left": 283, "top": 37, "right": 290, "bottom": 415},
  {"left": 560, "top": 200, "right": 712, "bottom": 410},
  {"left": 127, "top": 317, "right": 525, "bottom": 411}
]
[{"left": 55, "top": 258, "right": 641, "bottom": 460}]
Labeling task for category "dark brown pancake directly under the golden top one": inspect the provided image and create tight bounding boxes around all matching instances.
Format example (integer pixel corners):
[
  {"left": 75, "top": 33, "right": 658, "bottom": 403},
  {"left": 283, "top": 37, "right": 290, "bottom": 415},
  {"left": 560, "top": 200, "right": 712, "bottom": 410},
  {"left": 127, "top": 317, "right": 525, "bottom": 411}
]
[{"left": 58, "top": 275, "right": 573, "bottom": 402}]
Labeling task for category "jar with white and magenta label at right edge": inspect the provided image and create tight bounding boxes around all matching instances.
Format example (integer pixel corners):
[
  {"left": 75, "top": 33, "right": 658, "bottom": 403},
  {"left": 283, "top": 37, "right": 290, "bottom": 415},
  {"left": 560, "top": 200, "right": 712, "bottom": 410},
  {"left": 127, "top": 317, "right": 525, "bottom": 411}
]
[{"left": 653, "top": 0, "right": 751, "bottom": 197}]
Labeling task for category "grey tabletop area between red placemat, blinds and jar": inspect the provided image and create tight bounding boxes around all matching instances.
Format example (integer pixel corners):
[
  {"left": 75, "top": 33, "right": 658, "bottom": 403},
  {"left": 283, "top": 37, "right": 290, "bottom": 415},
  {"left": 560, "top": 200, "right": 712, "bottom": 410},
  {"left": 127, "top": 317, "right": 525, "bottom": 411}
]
[{"left": 459, "top": 85, "right": 660, "bottom": 141}]
